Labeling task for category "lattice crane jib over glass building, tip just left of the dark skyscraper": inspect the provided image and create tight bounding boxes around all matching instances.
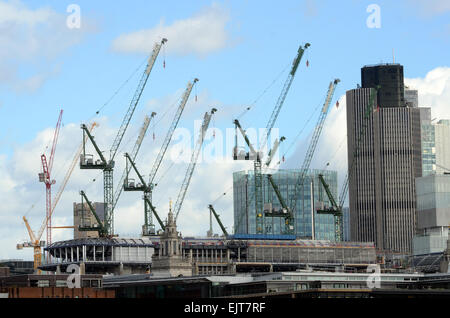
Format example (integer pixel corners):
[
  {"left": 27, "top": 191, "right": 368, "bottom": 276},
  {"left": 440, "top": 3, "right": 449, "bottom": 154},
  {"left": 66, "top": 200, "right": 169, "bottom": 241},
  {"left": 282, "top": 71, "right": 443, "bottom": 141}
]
[{"left": 290, "top": 79, "right": 340, "bottom": 217}]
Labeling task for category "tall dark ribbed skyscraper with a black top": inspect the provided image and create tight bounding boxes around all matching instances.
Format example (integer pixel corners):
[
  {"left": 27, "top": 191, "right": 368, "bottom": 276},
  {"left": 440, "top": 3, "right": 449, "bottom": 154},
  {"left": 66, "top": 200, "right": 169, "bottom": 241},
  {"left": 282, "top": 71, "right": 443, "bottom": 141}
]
[{"left": 346, "top": 64, "right": 422, "bottom": 253}]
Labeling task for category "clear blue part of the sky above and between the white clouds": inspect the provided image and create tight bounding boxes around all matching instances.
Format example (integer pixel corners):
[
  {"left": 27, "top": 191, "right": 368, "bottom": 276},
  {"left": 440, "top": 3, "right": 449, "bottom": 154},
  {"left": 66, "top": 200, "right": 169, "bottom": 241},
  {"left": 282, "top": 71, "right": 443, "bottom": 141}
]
[{"left": 0, "top": 1, "right": 449, "bottom": 154}]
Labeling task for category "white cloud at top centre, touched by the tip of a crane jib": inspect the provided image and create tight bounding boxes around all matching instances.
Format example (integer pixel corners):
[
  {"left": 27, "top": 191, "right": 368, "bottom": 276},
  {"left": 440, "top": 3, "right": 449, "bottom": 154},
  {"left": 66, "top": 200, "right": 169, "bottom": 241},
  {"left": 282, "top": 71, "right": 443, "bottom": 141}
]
[{"left": 112, "top": 4, "right": 229, "bottom": 56}]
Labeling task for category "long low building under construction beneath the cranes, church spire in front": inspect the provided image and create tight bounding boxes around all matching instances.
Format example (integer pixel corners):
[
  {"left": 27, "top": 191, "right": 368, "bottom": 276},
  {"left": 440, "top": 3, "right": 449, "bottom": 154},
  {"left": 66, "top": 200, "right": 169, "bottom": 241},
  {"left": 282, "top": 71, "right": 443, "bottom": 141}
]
[{"left": 37, "top": 211, "right": 376, "bottom": 277}]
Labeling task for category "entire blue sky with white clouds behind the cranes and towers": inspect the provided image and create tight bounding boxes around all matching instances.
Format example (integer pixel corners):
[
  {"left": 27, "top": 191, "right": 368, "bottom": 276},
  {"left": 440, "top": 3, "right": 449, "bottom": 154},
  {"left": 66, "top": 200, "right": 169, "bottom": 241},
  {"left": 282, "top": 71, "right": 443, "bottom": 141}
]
[{"left": 0, "top": 0, "right": 450, "bottom": 259}]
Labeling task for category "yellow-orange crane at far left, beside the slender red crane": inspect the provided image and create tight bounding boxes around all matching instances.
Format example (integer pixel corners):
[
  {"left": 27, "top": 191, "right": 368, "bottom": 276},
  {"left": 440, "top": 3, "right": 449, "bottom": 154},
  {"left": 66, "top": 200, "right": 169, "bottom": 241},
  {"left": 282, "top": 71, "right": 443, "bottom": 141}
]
[{"left": 17, "top": 122, "right": 98, "bottom": 272}]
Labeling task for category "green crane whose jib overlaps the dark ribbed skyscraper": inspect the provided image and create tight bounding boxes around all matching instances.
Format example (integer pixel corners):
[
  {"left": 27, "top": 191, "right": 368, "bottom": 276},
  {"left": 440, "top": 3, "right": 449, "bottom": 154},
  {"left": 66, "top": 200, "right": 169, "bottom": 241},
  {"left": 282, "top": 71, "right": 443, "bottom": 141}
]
[{"left": 317, "top": 86, "right": 380, "bottom": 242}]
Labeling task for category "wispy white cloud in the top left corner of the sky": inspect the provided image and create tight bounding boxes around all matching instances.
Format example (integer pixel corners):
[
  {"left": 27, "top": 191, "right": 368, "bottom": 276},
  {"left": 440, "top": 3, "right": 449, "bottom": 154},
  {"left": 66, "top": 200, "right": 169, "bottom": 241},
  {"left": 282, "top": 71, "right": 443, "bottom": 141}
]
[{"left": 0, "top": 0, "right": 93, "bottom": 93}]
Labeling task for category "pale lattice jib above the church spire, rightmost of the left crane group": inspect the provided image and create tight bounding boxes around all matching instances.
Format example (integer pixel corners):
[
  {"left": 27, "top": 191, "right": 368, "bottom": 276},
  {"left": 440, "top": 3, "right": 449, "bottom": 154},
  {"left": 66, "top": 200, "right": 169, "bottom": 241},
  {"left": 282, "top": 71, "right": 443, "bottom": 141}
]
[{"left": 174, "top": 108, "right": 217, "bottom": 221}]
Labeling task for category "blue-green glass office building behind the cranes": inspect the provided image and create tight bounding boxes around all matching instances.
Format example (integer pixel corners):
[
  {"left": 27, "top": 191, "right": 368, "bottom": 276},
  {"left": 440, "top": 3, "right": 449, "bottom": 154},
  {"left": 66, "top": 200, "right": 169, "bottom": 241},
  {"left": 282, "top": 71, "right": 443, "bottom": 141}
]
[{"left": 233, "top": 170, "right": 338, "bottom": 241}]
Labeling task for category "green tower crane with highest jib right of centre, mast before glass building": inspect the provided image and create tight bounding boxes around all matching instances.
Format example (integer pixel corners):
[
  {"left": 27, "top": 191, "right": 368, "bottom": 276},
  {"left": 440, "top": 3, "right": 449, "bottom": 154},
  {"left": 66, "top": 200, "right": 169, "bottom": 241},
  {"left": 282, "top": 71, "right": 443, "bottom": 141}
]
[{"left": 233, "top": 43, "right": 310, "bottom": 234}]
